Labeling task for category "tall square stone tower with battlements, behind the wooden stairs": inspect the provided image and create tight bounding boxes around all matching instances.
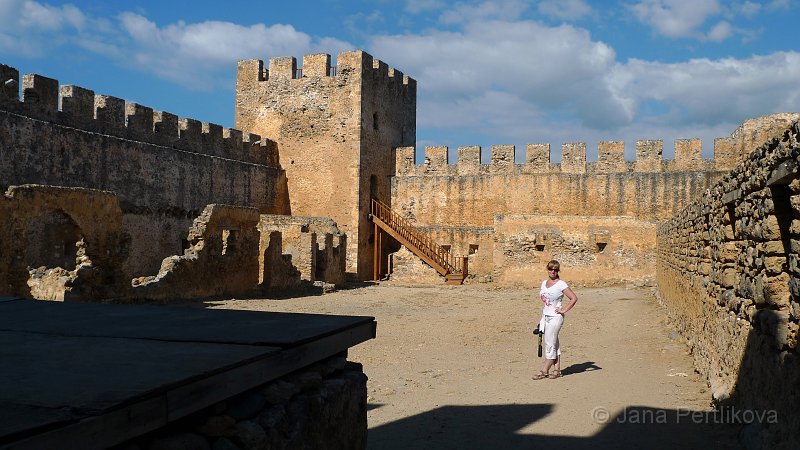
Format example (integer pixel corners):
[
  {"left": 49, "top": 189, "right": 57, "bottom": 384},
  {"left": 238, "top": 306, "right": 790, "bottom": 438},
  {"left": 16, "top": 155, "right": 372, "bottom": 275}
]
[{"left": 235, "top": 51, "right": 417, "bottom": 280}]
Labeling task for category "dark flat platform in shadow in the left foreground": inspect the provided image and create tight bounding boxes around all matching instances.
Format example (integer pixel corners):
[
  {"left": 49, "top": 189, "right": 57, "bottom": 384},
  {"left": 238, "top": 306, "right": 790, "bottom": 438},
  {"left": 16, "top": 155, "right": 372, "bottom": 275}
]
[{"left": 0, "top": 297, "right": 376, "bottom": 449}]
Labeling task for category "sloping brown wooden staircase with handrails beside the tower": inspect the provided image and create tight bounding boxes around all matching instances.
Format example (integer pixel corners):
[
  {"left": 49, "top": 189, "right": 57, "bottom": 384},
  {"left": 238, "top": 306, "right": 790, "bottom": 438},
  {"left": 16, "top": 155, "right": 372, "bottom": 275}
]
[{"left": 370, "top": 198, "right": 467, "bottom": 277}]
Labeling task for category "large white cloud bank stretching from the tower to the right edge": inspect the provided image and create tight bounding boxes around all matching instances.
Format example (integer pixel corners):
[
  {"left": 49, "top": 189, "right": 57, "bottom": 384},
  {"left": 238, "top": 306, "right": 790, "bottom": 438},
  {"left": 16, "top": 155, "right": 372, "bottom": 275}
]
[{"left": 368, "top": 15, "right": 800, "bottom": 156}]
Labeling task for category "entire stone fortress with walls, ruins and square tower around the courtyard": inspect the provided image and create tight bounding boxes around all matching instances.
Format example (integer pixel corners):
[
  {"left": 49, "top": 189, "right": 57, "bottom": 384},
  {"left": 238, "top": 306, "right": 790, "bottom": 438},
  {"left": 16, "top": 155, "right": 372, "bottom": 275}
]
[{"left": 0, "top": 51, "right": 800, "bottom": 446}]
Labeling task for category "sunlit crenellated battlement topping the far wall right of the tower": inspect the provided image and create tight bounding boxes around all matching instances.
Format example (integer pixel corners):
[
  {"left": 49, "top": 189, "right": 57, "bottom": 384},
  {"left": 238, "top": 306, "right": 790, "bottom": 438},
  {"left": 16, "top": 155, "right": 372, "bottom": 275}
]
[{"left": 395, "top": 138, "right": 737, "bottom": 176}]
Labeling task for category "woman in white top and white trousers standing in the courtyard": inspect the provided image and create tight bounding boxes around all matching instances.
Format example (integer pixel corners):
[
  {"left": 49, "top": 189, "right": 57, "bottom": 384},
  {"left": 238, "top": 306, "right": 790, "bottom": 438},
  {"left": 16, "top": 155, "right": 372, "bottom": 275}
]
[{"left": 533, "top": 260, "right": 578, "bottom": 380}]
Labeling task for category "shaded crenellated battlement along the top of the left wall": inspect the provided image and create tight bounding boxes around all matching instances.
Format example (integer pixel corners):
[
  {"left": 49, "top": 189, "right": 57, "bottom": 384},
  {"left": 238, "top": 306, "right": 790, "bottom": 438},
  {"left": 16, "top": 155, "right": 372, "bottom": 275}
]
[{"left": 0, "top": 64, "right": 278, "bottom": 167}]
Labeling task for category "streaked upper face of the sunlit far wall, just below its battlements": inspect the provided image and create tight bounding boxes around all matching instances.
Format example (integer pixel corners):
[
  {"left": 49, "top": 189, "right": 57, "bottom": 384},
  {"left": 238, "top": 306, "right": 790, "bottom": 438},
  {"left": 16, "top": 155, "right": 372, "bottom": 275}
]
[{"left": 392, "top": 142, "right": 724, "bottom": 227}]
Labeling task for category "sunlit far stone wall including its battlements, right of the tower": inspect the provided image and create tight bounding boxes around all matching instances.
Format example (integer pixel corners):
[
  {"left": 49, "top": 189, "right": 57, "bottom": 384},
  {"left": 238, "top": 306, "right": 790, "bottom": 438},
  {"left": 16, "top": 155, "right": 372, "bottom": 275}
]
[{"left": 391, "top": 114, "right": 800, "bottom": 285}]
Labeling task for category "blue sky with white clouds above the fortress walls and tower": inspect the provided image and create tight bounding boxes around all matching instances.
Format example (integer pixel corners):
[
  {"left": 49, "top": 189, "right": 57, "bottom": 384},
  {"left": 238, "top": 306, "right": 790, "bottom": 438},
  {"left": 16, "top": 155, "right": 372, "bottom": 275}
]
[{"left": 0, "top": 0, "right": 800, "bottom": 161}]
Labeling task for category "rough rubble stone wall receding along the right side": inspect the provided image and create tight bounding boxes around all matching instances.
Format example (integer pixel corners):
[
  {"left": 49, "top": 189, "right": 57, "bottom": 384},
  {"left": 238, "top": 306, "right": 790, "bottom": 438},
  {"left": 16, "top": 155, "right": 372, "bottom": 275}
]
[{"left": 656, "top": 122, "right": 800, "bottom": 448}]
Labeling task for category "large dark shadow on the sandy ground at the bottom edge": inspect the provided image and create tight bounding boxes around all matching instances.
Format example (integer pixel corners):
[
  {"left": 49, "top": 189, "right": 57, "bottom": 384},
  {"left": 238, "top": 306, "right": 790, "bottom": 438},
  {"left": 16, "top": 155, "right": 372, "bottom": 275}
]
[{"left": 368, "top": 404, "right": 741, "bottom": 450}]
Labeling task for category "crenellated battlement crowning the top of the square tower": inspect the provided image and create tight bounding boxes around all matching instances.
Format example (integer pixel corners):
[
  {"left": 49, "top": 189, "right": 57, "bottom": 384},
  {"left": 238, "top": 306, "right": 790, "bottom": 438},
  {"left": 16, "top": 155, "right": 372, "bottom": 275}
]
[{"left": 237, "top": 50, "right": 417, "bottom": 93}]
